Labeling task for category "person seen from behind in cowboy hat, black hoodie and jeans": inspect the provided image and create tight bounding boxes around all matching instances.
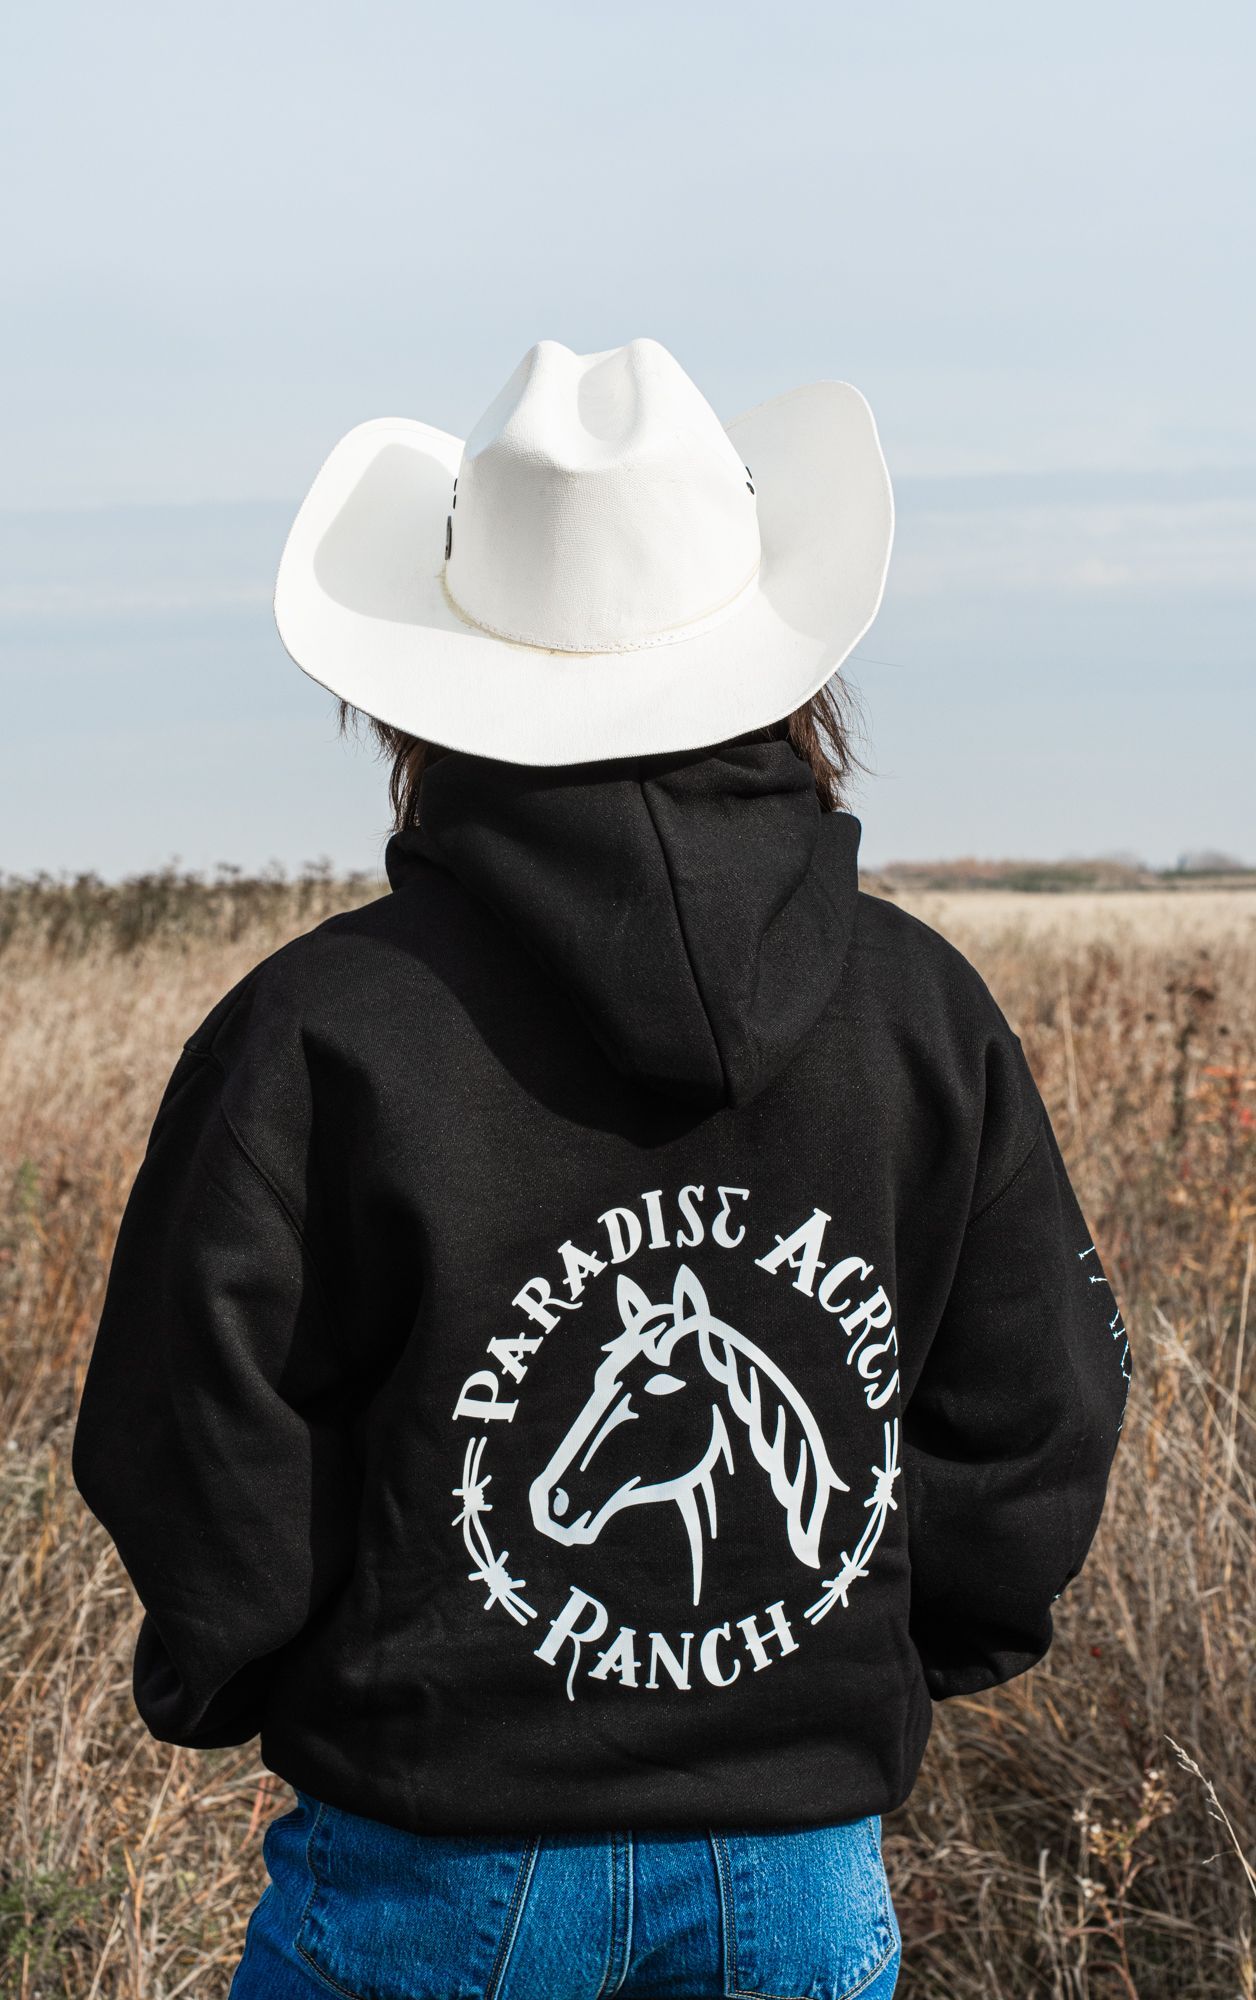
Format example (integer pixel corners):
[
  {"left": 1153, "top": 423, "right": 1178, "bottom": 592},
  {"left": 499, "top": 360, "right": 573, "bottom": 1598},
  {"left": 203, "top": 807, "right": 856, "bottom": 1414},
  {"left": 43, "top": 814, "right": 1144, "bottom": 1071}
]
[{"left": 74, "top": 340, "right": 1130, "bottom": 2000}]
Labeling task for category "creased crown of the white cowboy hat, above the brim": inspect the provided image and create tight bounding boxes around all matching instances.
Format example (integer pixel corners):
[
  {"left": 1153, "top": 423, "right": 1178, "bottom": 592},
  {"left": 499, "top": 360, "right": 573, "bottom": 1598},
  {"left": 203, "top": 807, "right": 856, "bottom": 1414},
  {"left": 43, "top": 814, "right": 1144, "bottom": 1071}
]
[{"left": 446, "top": 340, "right": 760, "bottom": 652}]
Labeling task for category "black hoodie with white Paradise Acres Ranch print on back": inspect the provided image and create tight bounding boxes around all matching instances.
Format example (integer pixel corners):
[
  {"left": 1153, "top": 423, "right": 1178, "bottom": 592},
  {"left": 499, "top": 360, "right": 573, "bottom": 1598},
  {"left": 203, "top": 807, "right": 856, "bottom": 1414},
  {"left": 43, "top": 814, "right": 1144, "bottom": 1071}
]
[{"left": 72, "top": 734, "right": 1130, "bottom": 1832}]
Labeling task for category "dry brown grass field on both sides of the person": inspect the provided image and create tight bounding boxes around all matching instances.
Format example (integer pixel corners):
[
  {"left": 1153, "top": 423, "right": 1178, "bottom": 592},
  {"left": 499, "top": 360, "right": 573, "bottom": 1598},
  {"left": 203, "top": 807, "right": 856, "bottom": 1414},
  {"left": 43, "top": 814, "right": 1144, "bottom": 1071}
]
[{"left": 0, "top": 872, "right": 1256, "bottom": 2000}]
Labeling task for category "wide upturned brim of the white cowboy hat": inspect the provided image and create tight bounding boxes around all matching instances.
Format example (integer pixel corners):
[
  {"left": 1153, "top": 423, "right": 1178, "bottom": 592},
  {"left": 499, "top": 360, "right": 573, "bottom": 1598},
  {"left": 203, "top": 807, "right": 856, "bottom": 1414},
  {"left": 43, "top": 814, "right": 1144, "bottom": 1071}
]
[{"left": 274, "top": 382, "right": 894, "bottom": 764}]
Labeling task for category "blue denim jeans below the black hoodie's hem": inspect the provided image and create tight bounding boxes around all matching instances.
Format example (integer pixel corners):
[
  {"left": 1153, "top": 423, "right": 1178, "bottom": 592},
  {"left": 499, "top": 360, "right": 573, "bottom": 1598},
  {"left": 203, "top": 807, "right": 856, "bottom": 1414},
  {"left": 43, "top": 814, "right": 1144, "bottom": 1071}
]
[{"left": 228, "top": 1790, "right": 902, "bottom": 2000}]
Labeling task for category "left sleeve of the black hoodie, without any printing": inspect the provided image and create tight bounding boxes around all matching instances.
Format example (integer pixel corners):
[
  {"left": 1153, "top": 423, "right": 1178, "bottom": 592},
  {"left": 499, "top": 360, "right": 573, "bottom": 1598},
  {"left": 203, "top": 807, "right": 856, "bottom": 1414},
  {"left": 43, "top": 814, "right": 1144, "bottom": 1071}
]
[{"left": 72, "top": 1042, "right": 356, "bottom": 1748}]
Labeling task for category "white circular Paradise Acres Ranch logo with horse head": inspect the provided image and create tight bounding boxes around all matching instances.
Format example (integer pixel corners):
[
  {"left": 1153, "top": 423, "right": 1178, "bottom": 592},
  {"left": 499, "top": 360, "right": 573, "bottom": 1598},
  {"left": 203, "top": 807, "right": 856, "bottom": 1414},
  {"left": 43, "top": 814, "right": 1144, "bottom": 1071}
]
[{"left": 454, "top": 1184, "right": 900, "bottom": 1700}]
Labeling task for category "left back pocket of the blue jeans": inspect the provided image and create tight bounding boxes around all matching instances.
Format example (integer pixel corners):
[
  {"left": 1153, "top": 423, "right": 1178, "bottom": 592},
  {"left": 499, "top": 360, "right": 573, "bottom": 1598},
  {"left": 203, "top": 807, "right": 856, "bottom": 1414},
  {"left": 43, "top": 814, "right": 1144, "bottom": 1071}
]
[{"left": 292, "top": 1800, "right": 540, "bottom": 2000}]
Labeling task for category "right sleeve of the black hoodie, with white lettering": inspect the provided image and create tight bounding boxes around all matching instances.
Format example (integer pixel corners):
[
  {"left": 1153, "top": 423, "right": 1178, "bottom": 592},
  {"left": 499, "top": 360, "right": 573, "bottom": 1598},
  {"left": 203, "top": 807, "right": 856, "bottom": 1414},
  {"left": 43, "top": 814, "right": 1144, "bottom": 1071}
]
[{"left": 904, "top": 1066, "right": 1132, "bottom": 1700}]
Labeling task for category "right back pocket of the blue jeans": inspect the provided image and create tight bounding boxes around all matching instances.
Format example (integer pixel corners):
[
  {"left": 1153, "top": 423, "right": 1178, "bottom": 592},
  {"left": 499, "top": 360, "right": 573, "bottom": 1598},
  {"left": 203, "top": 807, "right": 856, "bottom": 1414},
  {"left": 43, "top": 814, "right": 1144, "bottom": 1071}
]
[{"left": 712, "top": 1814, "right": 902, "bottom": 2000}]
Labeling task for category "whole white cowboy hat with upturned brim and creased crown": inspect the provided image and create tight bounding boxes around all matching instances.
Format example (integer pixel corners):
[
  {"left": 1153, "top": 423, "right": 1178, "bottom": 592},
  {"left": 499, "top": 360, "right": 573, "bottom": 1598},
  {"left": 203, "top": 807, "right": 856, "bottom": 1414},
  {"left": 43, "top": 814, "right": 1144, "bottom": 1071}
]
[{"left": 274, "top": 340, "right": 894, "bottom": 764}]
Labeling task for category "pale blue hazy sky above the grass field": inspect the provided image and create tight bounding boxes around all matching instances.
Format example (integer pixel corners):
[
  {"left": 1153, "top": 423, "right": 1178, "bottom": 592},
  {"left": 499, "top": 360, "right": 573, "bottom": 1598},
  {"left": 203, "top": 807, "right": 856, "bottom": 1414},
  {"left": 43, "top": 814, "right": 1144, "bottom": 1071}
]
[{"left": 0, "top": 0, "right": 1256, "bottom": 876}]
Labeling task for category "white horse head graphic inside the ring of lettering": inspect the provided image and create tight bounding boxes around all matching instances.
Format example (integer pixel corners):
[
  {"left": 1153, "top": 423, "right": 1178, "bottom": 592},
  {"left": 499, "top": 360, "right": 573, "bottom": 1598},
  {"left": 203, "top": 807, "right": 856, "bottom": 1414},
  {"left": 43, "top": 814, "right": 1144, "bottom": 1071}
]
[{"left": 528, "top": 1264, "right": 850, "bottom": 1604}]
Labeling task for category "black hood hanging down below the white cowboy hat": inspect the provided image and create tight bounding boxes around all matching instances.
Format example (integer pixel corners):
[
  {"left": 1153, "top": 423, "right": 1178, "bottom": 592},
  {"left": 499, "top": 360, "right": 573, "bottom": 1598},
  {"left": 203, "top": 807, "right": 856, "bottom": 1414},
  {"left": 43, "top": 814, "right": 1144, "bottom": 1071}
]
[{"left": 384, "top": 734, "right": 860, "bottom": 1110}]
